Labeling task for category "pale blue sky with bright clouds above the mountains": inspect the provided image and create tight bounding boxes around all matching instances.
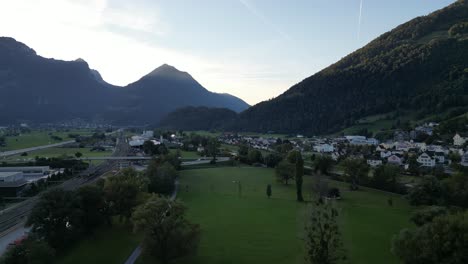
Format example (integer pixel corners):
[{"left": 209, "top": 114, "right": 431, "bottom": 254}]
[{"left": 0, "top": 0, "right": 454, "bottom": 105}]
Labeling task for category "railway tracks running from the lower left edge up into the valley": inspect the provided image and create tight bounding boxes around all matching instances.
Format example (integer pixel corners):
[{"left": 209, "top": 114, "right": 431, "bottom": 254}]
[{"left": 0, "top": 133, "right": 129, "bottom": 255}]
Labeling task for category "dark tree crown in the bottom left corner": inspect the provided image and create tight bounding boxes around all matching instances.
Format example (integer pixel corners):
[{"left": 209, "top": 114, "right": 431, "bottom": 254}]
[{"left": 0, "top": 238, "right": 55, "bottom": 264}]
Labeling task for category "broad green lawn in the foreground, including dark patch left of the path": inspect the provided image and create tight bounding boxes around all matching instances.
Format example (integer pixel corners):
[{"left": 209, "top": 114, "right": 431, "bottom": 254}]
[{"left": 59, "top": 167, "right": 411, "bottom": 264}]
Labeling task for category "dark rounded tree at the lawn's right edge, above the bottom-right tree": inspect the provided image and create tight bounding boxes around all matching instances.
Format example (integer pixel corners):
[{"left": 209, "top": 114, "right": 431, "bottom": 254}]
[{"left": 408, "top": 176, "right": 443, "bottom": 205}]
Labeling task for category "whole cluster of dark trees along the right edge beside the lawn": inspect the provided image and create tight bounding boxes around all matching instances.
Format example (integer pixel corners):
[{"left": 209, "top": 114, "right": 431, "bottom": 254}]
[{"left": 392, "top": 164, "right": 468, "bottom": 264}]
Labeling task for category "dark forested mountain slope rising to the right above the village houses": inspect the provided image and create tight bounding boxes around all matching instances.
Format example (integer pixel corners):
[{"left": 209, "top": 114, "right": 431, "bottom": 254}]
[{"left": 238, "top": 0, "right": 468, "bottom": 134}]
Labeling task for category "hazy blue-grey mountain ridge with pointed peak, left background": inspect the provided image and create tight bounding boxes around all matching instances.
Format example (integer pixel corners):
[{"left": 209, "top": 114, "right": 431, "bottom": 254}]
[{"left": 0, "top": 37, "right": 248, "bottom": 125}]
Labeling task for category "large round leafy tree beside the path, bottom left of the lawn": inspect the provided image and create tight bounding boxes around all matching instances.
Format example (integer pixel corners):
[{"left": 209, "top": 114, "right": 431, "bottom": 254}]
[{"left": 132, "top": 196, "right": 200, "bottom": 264}]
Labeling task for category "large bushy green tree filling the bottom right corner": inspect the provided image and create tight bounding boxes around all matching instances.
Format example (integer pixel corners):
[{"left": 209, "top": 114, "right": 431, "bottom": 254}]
[{"left": 392, "top": 212, "right": 468, "bottom": 264}]
